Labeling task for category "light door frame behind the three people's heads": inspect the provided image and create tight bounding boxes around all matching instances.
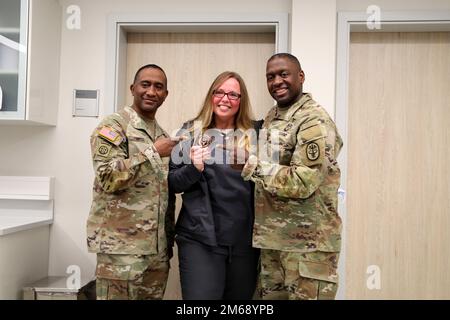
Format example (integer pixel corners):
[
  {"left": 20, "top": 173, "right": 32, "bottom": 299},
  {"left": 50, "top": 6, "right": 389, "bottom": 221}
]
[{"left": 104, "top": 13, "right": 289, "bottom": 114}]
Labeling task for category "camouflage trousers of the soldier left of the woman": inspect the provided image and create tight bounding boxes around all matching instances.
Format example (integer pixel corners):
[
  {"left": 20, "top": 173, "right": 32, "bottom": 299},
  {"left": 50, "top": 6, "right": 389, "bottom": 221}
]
[{"left": 95, "top": 253, "right": 169, "bottom": 300}]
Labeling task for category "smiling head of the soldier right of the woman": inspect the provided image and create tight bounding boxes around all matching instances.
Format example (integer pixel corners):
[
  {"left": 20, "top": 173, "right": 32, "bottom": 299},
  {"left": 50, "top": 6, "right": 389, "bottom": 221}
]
[{"left": 266, "top": 57, "right": 305, "bottom": 108}]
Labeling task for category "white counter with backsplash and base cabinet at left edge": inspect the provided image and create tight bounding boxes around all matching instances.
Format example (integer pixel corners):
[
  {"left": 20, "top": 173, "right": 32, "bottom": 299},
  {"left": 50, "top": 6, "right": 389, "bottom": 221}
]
[{"left": 0, "top": 176, "right": 54, "bottom": 300}]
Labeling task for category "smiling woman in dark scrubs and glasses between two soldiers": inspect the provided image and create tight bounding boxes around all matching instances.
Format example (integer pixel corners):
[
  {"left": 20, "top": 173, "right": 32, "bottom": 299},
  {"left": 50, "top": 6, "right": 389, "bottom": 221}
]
[{"left": 169, "top": 71, "right": 259, "bottom": 300}]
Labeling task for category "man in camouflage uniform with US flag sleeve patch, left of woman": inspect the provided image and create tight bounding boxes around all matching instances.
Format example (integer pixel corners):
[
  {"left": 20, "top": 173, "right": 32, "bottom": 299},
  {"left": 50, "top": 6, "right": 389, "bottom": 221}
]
[{"left": 87, "top": 65, "right": 176, "bottom": 300}]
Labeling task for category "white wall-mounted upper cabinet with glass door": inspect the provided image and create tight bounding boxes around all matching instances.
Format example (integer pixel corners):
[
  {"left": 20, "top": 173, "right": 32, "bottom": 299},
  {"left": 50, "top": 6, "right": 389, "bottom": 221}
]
[{"left": 0, "top": 0, "right": 62, "bottom": 125}]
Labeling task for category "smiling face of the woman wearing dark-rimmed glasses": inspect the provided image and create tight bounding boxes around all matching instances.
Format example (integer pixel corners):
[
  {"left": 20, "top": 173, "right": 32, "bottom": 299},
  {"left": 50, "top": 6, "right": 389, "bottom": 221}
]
[{"left": 212, "top": 78, "right": 241, "bottom": 121}]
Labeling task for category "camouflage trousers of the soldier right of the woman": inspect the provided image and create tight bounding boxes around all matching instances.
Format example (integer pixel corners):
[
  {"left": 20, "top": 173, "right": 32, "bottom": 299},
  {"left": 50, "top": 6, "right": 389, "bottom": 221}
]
[{"left": 258, "top": 249, "right": 339, "bottom": 300}]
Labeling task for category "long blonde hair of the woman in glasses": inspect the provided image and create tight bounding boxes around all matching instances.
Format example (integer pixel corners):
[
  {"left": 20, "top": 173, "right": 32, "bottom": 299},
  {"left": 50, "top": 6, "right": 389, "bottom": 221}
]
[{"left": 193, "top": 71, "right": 253, "bottom": 132}]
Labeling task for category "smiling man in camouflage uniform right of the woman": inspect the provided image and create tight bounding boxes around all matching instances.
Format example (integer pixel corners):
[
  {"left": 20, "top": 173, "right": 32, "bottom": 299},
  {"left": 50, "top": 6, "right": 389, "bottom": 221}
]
[{"left": 242, "top": 53, "right": 342, "bottom": 300}]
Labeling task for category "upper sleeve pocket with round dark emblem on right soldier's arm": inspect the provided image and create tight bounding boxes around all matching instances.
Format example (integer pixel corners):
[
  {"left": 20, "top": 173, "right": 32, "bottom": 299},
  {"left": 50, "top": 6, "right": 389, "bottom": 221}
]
[{"left": 299, "top": 123, "right": 326, "bottom": 166}]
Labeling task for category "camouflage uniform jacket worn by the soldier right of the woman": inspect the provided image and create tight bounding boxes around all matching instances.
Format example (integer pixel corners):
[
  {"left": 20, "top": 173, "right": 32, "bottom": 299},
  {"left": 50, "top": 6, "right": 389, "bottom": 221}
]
[{"left": 242, "top": 93, "right": 342, "bottom": 252}]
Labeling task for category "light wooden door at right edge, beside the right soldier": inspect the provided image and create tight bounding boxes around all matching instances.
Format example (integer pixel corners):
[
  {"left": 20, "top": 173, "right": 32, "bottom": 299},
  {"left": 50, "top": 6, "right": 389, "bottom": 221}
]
[{"left": 346, "top": 32, "right": 450, "bottom": 299}]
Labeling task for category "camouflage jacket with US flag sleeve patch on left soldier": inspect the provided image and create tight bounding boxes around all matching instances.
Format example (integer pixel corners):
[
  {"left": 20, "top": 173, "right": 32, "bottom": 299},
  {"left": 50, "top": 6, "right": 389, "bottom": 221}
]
[{"left": 87, "top": 107, "right": 174, "bottom": 255}]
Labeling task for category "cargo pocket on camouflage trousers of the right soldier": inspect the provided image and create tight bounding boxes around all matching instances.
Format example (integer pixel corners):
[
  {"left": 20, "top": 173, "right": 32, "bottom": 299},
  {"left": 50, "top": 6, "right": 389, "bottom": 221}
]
[{"left": 298, "top": 253, "right": 338, "bottom": 300}]
